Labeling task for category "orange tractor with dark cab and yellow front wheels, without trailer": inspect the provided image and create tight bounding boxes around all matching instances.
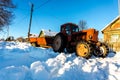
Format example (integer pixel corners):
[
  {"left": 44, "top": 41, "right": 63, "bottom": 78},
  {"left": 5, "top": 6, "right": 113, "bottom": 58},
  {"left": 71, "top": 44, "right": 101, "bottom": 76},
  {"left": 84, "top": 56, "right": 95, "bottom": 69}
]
[{"left": 52, "top": 23, "right": 109, "bottom": 59}]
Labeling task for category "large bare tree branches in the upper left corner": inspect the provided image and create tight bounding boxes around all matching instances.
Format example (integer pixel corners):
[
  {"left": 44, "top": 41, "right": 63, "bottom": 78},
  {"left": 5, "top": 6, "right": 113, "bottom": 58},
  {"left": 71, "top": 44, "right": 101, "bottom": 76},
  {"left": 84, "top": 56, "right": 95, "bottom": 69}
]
[{"left": 0, "top": 0, "right": 15, "bottom": 31}]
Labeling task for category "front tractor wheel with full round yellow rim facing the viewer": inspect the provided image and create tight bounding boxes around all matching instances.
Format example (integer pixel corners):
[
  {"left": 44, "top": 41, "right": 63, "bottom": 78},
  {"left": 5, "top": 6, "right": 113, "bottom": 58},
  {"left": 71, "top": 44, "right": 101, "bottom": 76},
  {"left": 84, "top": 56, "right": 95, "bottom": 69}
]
[{"left": 76, "top": 41, "right": 93, "bottom": 59}]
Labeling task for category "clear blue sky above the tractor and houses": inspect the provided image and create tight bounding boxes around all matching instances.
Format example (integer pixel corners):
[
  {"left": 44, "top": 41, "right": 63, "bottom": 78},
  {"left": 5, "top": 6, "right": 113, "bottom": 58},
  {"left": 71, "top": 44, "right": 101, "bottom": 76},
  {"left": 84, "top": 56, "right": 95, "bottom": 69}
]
[{"left": 5, "top": 0, "right": 118, "bottom": 38}]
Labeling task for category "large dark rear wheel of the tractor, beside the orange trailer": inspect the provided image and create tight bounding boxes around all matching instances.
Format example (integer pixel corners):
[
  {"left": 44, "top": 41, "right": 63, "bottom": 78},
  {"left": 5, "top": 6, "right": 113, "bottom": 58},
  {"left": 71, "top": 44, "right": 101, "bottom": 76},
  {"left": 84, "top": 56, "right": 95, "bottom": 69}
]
[{"left": 52, "top": 34, "right": 65, "bottom": 52}]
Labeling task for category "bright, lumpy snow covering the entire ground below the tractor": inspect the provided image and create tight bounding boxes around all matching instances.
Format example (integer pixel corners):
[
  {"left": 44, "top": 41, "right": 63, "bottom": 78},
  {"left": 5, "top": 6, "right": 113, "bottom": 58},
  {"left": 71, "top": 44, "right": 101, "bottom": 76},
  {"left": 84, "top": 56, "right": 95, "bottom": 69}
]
[{"left": 0, "top": 42, "right": 120, "bottom": 80}]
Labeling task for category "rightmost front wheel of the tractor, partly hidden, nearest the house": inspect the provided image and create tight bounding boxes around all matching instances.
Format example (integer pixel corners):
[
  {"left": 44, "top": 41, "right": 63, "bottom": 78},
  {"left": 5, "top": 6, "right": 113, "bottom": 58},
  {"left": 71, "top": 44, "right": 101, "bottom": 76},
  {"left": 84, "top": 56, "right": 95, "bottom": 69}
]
[{"left": 94, "top": 43, "right": 109, "bottom": 58}]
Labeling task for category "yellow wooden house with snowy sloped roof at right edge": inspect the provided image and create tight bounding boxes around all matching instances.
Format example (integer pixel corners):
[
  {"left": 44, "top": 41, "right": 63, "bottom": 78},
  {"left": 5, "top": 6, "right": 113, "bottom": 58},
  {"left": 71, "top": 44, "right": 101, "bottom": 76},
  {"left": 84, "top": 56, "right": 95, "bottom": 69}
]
[{"left": 102, "top": 16, "right": 120, "bottom": 52}]
